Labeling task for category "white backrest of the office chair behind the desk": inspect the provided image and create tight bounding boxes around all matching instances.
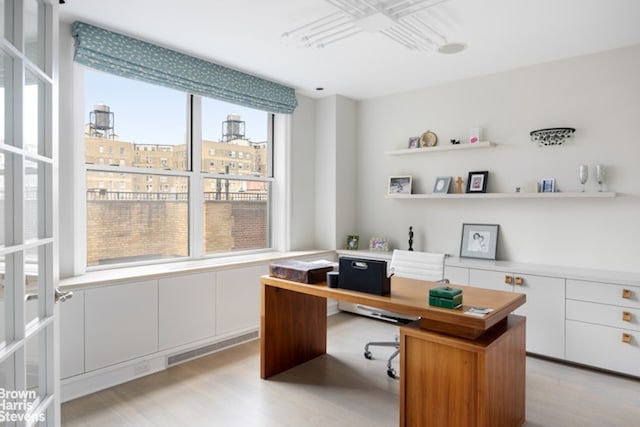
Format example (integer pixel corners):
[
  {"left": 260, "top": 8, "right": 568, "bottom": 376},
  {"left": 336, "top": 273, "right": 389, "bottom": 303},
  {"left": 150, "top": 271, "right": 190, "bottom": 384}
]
[{"left": 387, "top": 249, "right": 445, "bottom": 282}]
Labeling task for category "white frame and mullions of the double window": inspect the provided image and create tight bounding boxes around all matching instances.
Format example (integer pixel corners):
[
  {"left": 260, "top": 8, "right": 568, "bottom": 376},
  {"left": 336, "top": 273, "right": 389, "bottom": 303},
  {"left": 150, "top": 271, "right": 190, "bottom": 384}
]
[{"left": 81, "top": 70, "right": 276, "bottom": 273}]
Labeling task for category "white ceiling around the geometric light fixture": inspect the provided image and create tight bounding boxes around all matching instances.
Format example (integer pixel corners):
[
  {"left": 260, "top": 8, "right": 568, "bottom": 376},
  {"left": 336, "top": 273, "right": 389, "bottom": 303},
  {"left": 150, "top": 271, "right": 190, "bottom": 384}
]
[{"left": 60, "top": 0, "right": 640, "bottom": 100}]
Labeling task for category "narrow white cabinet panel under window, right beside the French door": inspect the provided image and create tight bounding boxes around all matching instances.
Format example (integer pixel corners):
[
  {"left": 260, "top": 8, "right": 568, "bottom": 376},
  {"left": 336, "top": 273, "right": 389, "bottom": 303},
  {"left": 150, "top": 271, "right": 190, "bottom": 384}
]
[{"left": 58, "top": 290, "right": 84, "bottom": 379}]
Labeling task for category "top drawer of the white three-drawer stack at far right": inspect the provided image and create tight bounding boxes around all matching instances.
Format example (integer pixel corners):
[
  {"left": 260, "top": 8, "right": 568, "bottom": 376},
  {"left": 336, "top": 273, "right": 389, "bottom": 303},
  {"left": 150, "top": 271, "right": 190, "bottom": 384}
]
[{"left": 567, "top": 279, "right": 640, "bottom": 308}]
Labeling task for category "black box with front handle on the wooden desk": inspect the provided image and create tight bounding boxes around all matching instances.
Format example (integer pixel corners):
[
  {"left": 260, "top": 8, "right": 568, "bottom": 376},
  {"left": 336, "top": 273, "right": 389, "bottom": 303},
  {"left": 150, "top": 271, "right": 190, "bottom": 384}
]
[{"left": 338, "top": 257, "right": 391, "bottom": 295}]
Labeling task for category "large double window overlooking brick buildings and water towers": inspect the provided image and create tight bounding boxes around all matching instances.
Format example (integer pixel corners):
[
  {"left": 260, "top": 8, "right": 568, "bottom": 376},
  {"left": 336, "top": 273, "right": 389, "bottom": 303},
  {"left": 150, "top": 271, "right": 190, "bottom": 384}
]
[{"left": 84, "top": 68, "right": 272, "bottom": 267}]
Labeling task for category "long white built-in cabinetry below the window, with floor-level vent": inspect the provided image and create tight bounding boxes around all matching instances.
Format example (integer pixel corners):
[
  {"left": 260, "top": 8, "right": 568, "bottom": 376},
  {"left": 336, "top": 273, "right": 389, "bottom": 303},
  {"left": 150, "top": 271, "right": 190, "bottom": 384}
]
[{"left": 60, "top": 251, "right": 334, "bottom": 401}]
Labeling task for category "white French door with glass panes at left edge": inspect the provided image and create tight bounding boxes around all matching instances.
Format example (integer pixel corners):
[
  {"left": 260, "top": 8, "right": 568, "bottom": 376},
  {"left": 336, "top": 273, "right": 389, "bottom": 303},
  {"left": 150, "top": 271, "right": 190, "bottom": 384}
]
[{"left": 0, "top": 0, "right": 60, "bottom": 426}]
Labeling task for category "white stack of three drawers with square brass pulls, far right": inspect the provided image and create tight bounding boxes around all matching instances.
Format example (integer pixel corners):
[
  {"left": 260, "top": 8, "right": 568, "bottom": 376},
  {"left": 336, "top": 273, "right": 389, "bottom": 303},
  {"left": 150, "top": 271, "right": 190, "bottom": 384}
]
[{"left": 566, "top": 280, "right": 640, "bottom": 376}]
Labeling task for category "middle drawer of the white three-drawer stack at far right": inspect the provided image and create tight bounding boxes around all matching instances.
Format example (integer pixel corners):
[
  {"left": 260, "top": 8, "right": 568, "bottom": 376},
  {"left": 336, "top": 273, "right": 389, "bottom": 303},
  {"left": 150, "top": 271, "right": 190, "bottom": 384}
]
[{"left": 566, "top": 300, "right": 640, "bottom": 331}]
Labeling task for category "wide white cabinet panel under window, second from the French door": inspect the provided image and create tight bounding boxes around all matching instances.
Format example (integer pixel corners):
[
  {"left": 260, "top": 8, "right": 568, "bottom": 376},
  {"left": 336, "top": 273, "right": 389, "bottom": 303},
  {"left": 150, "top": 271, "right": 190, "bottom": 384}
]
[{"left": 85, "top": 280, "right": 158, "bottom": 371}]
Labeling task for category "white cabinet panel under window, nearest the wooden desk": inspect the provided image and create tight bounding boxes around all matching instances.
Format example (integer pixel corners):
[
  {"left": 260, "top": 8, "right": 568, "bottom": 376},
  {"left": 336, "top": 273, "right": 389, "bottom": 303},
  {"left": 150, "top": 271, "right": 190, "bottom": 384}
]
[{"left": 215, "top": 265, "right": 269, "bottom": 335}]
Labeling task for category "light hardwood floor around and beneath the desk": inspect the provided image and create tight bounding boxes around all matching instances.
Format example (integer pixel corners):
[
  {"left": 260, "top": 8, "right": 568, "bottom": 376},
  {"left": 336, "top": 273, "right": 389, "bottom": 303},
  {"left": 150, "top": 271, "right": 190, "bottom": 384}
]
[{"left": 62, "top": 313, "right": 640, "bottom": 427}]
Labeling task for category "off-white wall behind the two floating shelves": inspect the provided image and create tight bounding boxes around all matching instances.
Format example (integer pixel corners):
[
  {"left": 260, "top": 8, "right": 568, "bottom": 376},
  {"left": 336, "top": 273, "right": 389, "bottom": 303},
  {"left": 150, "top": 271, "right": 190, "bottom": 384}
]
[{"left": 356, "top": 46, "right": 640, "bottom": 271}]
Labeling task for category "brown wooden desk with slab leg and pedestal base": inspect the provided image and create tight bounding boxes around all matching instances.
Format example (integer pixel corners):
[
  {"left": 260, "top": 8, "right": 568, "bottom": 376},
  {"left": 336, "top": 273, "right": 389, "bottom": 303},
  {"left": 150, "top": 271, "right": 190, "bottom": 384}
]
[{"left": 260, "top": 276, "right": 526, "bottom": 426}]
